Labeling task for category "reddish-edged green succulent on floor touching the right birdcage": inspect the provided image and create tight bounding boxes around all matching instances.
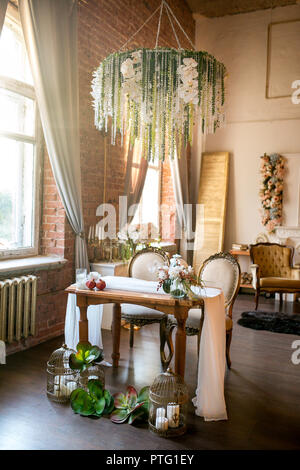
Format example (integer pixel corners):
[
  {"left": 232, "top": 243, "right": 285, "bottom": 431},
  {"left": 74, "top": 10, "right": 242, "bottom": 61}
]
[{"left": 110, "top": 385, "right": 149, "bottom": 424}]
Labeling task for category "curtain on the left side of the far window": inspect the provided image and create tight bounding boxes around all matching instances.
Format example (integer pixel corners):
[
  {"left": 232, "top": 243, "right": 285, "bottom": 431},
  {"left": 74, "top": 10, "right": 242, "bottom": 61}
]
[{"left": 120, "top": 133, "right": 148, "bottom": 229}]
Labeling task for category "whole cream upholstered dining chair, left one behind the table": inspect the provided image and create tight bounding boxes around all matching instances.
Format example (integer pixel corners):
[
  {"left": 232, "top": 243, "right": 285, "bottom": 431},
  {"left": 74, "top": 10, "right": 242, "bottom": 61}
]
[{"left": 121, "top": 247, "right": 170, "bottom": 356}]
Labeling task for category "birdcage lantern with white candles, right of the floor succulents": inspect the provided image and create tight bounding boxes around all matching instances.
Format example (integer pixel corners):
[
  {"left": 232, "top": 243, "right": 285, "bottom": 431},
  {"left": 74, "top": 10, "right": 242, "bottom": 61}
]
[{"left": 149, "top": 369, "right": 188, "bottom": 437}]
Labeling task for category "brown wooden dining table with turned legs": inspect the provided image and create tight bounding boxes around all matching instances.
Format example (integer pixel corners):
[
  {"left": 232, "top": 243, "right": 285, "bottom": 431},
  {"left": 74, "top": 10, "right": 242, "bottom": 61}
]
[{"left": 66, "top": 285, "right": 203, "bottom": 377}]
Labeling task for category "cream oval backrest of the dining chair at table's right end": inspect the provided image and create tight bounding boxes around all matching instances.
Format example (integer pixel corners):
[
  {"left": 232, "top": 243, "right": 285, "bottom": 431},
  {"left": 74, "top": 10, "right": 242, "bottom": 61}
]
[{"left": 198, "top": 252, "right": 241, "bottom": 307}]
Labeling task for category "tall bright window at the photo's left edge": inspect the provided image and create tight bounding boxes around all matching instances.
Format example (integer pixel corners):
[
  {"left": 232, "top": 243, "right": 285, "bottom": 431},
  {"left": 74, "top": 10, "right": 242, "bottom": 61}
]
[{"left": 0, "top": 8, "right": 39, "bottom": 258}]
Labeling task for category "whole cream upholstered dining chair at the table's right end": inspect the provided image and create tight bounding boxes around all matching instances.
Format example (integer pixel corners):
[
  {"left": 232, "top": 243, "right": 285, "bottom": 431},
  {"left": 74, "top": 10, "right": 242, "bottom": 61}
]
[{"left": 164, "top": 252, "right": 241, "bottom": 369}]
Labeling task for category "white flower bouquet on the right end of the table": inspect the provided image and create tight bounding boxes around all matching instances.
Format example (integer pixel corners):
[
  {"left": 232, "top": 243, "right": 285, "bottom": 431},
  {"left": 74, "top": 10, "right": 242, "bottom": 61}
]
[{"left": 157, "top": 255, "right": 202, "bottom": 299}]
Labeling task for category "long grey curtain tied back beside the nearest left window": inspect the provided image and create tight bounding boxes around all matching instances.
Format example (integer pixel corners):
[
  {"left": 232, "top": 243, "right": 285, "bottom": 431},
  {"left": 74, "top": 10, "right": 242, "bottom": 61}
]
[{"left": 19, "top": 0, "right": 89, "bottom": 270}]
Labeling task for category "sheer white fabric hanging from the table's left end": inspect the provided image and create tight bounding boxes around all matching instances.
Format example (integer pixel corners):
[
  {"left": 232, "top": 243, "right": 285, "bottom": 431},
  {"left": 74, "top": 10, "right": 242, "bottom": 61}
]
[{"left": 65, "top": 294, "right": 103, "bottom": 349}]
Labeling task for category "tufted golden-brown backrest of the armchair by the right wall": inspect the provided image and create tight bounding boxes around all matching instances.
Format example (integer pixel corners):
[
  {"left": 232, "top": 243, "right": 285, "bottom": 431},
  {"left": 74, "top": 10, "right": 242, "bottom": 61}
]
[{"left": 250, "top": 243, "right": 294, "bottom": 277}]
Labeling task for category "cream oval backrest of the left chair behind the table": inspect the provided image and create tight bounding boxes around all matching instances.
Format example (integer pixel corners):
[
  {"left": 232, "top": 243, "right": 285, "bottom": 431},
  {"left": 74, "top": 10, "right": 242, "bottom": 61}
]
[{"left": 128, "top": 247, "right": 170, "bottom": 281}]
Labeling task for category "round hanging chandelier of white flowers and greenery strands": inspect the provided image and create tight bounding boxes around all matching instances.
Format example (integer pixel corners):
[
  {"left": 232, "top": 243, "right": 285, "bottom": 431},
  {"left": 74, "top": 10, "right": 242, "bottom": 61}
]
[{"left": 92, "top": 0, "right": 226, "bottom": 161}]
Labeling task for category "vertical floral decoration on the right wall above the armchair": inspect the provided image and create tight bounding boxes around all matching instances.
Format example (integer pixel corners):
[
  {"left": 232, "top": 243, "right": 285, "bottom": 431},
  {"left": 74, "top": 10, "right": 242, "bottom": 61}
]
[{"left": 259, "top": 153, "right": 284, "bottom": 232}]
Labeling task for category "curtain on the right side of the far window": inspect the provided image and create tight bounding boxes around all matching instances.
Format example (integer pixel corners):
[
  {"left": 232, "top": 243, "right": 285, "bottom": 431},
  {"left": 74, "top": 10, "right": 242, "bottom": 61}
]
[{"left": 170, "top": 118, "right": 205, "bottom": 265}]
